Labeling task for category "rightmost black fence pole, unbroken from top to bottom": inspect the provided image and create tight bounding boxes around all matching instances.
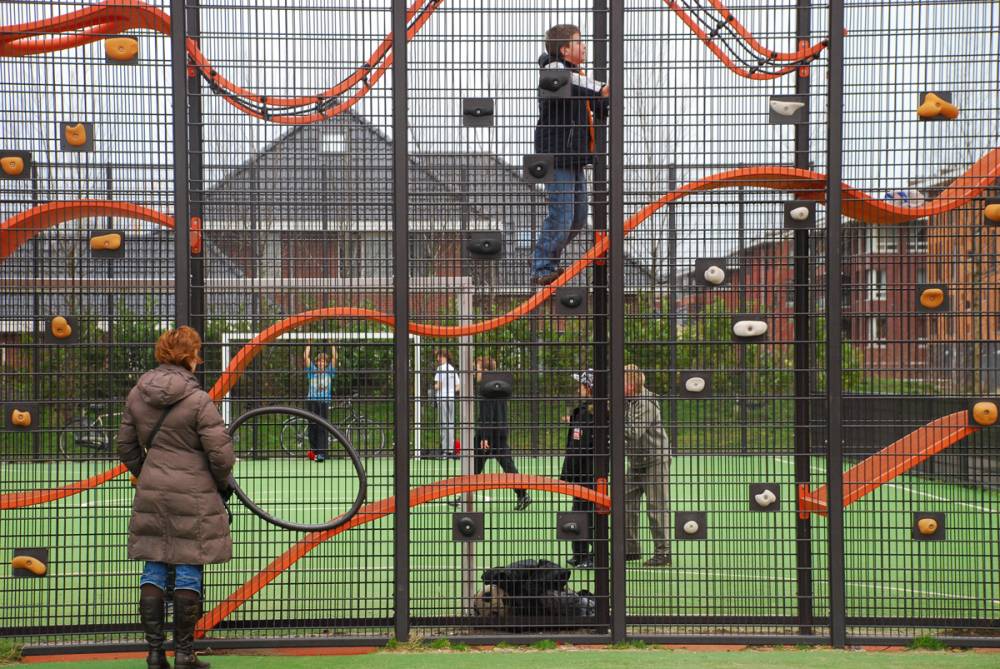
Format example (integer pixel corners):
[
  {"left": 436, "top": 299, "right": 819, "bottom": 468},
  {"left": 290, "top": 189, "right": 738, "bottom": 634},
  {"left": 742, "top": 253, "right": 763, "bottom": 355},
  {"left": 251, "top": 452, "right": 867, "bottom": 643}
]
[{"left": 826, "top": 1, "right": 847, "bottom": 648}]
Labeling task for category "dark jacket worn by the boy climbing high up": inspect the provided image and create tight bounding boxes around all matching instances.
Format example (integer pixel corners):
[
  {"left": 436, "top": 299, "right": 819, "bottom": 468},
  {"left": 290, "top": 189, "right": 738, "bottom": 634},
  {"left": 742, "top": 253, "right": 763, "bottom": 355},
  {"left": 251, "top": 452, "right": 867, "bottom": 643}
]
[{"left": 535, "top": 53, "right": 609, "bottom": 168}]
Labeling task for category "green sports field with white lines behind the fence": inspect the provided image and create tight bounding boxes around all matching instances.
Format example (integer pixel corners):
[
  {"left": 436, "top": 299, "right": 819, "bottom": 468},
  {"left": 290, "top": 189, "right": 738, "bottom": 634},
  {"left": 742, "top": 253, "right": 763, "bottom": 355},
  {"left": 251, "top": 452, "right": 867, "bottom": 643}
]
[{"left": 0, "top": 455, "right": 1000, "bottom": 642}]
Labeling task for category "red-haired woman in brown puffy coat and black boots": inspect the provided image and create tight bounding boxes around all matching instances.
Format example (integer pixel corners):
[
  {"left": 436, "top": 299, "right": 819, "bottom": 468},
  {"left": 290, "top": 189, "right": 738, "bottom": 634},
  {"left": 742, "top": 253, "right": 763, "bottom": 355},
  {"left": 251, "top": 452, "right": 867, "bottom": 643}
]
[{"left": 118, "top": 326, "right": 235, "bottom": 669}]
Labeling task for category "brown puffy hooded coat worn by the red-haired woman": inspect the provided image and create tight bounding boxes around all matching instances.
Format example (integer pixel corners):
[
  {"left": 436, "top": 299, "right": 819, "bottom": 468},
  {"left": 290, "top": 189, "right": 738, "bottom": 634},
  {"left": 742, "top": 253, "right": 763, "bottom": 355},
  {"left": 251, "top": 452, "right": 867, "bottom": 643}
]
[{"left": 118, "top": 365, "right": 236, "bottom": 564}]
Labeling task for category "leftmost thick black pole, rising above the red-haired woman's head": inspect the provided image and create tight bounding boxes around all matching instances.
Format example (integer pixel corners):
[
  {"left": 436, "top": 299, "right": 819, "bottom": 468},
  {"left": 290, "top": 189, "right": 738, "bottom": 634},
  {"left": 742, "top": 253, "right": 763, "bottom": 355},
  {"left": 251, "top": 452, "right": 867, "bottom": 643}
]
[{"left": 170, "top": 0, "right": 191, "bottom": 327}]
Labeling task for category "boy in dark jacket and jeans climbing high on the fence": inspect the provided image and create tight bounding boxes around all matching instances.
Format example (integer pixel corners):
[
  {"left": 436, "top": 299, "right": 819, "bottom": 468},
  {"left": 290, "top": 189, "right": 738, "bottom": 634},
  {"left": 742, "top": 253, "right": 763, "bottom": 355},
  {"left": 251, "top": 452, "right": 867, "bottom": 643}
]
[{"left": 531, "top": 24, "right": 609, "bottom": 285}]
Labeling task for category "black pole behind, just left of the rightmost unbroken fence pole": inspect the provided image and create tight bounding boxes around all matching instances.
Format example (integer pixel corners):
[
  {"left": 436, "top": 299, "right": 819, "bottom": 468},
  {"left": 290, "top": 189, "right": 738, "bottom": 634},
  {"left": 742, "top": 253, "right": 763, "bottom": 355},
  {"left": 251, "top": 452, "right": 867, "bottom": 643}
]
[{"left": 792, "top": 0, "right": 813, "bottom": 634}]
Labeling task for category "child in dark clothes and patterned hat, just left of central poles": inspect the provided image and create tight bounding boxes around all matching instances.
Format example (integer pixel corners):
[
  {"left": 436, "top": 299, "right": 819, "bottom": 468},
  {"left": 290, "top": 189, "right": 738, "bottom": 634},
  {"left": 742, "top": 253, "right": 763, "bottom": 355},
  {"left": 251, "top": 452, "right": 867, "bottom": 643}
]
[{"left": 559, "top": 369, "right": 596, "bottom": 569}]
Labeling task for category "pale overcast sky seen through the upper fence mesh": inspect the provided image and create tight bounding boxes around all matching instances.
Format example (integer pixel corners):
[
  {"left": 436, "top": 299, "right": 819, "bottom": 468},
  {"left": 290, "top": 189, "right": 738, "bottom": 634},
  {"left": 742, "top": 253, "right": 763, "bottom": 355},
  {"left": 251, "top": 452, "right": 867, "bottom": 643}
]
[{"left": 0, "top": 0, "right": 1000, "bottom": 254}]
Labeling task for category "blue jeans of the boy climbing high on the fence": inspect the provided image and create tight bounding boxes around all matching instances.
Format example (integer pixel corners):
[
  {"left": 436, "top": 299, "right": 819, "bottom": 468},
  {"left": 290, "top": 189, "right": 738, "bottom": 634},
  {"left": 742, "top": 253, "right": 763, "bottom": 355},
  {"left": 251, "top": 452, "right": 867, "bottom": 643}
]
[{"left": 531, "top": 167, "right": 589, "bottom": 276}]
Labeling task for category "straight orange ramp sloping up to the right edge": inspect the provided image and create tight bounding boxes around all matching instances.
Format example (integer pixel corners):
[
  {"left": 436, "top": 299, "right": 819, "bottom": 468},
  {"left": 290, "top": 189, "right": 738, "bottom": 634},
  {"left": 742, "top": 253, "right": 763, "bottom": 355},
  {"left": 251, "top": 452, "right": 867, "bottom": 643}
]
[{"left": 799, "top": 411, "right": 980, "bottom": 518}]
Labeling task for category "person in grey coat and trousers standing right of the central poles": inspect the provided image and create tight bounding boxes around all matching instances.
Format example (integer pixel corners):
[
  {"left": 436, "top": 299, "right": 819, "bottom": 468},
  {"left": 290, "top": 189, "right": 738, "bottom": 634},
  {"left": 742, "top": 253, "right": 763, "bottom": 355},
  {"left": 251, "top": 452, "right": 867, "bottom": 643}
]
[{"left": 625, "top": 365, "right": 671, "bottom": 567}]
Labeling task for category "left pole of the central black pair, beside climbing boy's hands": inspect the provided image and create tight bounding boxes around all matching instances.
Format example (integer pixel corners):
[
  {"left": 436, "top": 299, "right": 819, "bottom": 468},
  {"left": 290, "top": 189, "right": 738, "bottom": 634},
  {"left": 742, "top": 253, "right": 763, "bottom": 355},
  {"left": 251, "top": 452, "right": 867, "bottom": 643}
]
[{"left": 591, "top": 0, "right": 611, "bottom": 627}]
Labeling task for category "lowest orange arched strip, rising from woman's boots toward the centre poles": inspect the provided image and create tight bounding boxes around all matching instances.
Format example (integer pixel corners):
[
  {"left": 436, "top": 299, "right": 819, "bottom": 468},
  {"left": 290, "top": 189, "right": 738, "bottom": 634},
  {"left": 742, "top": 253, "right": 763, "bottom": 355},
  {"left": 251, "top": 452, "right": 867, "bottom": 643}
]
[{"left": 195, "top": 474, "right": 611, "bottom": 638}]
